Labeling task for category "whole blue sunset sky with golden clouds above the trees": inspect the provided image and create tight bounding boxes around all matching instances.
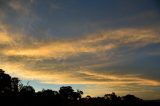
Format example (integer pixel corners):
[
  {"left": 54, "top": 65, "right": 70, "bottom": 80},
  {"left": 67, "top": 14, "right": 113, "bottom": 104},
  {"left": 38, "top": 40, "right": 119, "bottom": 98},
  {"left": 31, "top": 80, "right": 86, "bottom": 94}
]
[{"left": 0, "top": 0, "right": 160, "bottom": 99}]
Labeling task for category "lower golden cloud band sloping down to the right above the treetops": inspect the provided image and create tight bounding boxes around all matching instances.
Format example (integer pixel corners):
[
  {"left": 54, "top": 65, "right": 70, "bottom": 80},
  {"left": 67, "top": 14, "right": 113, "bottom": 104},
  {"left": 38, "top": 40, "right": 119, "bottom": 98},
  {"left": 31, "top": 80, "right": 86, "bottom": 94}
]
[{"left": 0, "top": 62, "right": 160, "bottom": 86}]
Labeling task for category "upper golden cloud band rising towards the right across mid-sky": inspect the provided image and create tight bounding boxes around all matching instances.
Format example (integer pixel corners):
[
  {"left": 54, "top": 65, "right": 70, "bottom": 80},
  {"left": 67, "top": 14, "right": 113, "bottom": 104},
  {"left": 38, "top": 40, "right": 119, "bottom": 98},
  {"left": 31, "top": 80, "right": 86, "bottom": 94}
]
[{"left": 1, "top": 29, "right": 160, "bottom": 58}]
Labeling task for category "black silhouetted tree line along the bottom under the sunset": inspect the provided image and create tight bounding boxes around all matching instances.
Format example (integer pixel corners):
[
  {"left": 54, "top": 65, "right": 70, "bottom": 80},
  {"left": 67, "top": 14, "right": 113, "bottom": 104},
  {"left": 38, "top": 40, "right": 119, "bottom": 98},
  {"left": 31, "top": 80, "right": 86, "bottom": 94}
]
[{"left": 0, "top": 69, "right": 158, "bottom": 106}]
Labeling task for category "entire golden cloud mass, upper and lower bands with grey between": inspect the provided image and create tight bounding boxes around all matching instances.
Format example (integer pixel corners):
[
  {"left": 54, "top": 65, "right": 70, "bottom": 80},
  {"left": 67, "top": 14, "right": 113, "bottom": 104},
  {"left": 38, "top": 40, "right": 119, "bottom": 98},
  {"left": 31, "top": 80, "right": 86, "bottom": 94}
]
[{"left": 0, "top": 27, "right": 160, "bottom": 98}]
